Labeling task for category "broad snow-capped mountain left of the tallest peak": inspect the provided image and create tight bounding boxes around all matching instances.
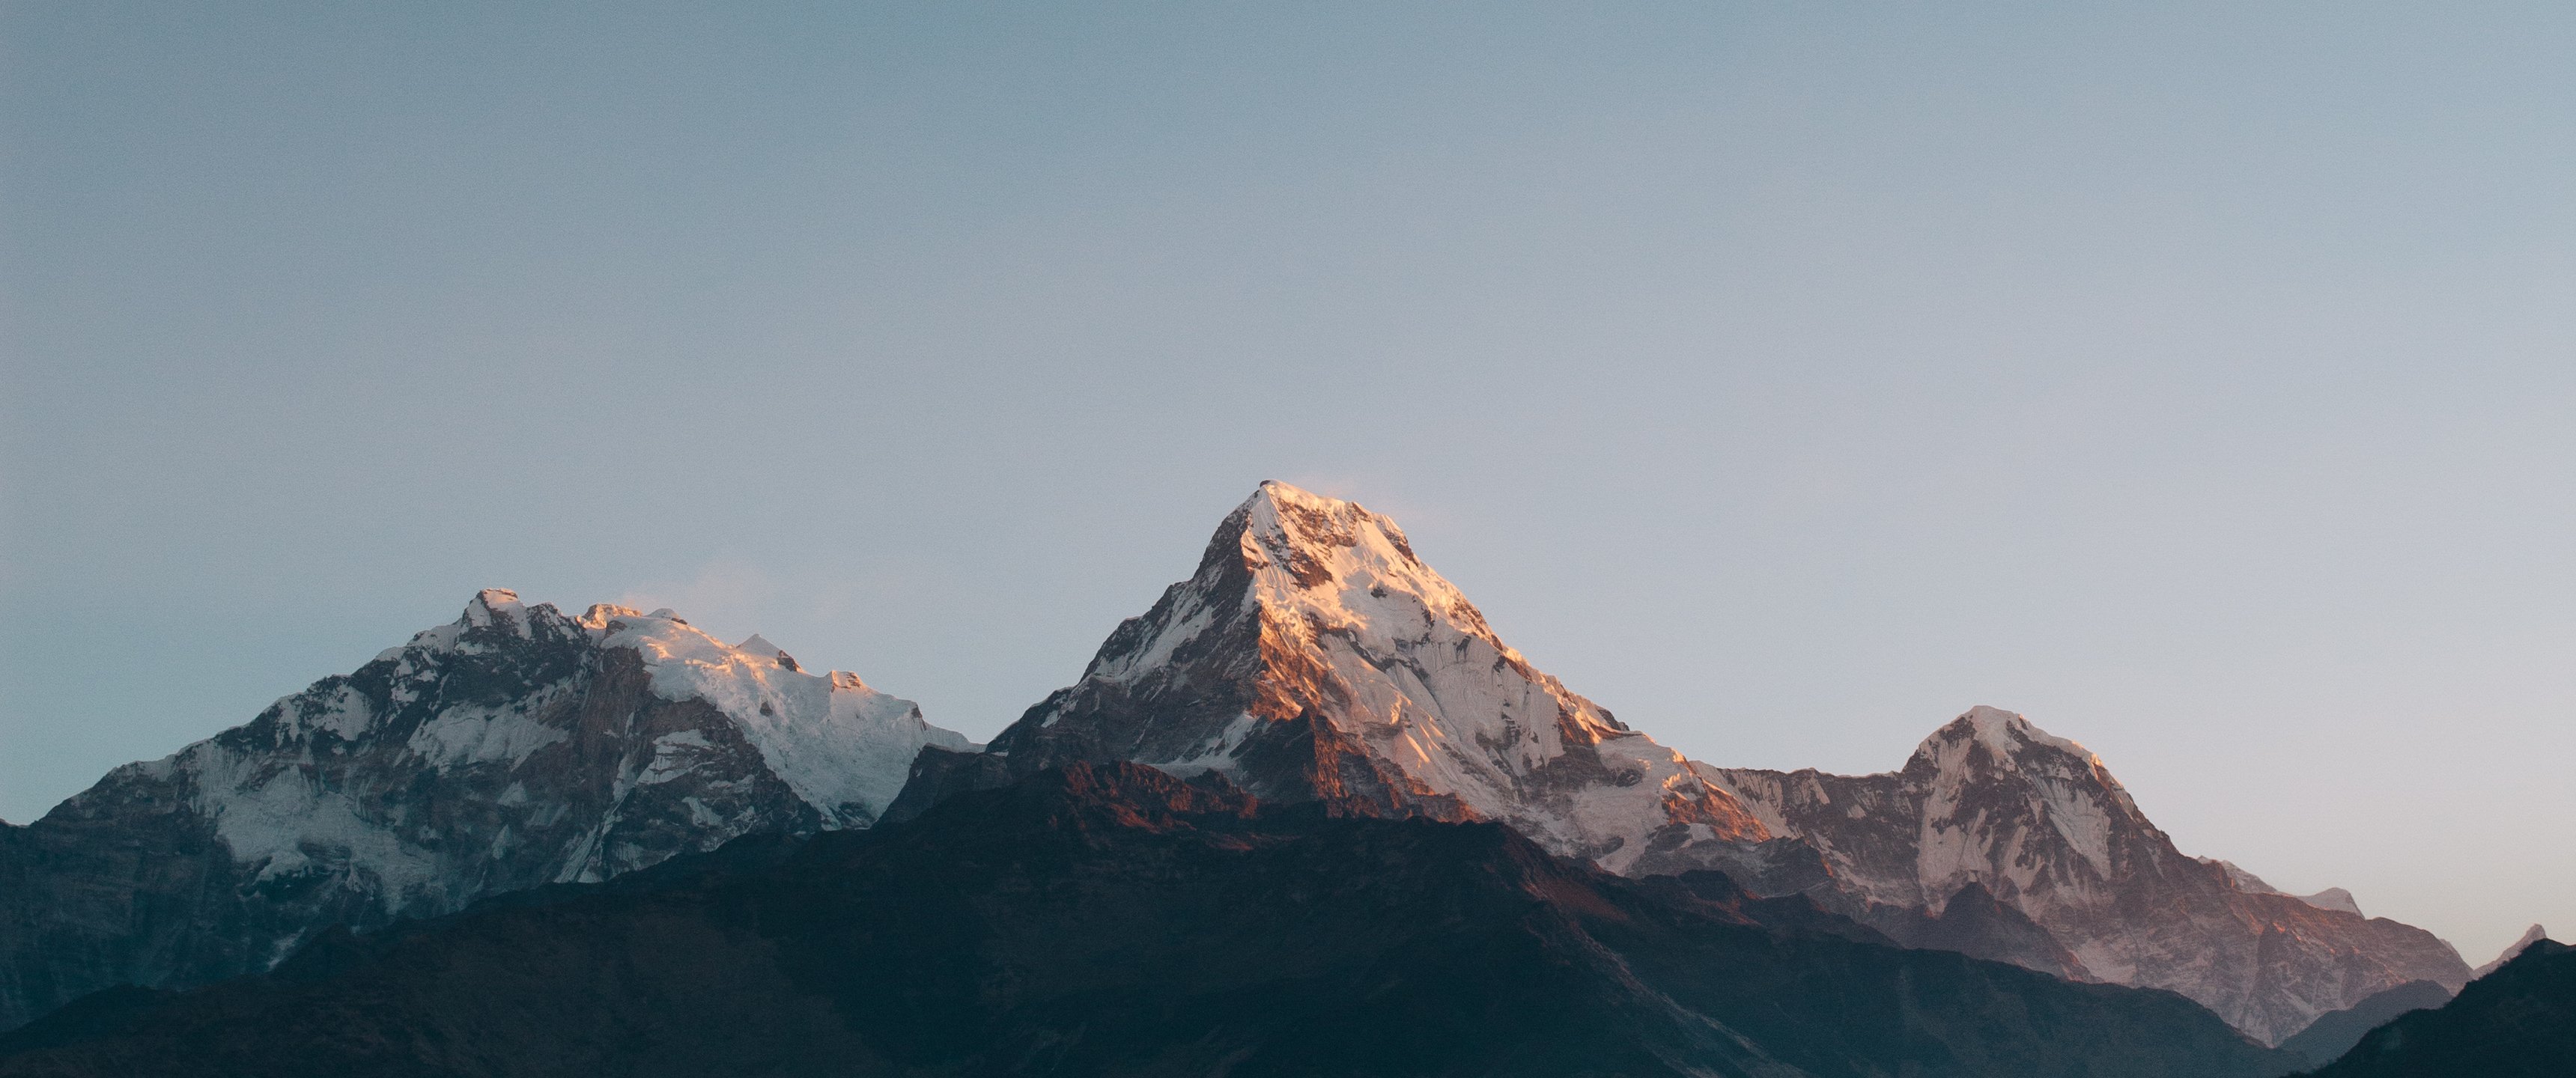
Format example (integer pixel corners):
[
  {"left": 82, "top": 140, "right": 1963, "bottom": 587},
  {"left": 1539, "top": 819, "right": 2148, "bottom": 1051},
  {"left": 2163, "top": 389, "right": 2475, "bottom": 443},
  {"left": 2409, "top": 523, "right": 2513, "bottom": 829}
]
[{"left": 0, "top": 589, "right": 971, "bottom": 1029}]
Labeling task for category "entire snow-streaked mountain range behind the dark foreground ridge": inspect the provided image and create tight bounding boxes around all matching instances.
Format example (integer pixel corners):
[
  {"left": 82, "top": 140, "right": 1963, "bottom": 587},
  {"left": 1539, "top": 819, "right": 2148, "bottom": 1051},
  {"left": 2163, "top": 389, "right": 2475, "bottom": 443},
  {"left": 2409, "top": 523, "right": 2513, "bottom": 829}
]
[{"left": 0, "top": 481, "right": 2470, "bottom": 1044}]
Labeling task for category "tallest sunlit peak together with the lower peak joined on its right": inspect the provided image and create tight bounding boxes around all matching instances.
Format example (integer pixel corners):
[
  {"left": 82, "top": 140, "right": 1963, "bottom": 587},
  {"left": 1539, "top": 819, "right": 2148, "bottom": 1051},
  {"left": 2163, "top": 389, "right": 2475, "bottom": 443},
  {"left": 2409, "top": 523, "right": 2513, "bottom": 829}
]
[{"left": 973, "top": 484, "right": 2468, "bottom": 1042}]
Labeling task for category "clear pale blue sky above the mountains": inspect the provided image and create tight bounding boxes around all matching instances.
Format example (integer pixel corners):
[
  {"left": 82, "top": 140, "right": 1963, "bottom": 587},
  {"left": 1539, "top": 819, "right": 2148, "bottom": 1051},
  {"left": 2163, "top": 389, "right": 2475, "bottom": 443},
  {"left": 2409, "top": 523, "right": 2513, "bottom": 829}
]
[{"left": 0, "top": 0, "right": 2576, "bottom": 962}]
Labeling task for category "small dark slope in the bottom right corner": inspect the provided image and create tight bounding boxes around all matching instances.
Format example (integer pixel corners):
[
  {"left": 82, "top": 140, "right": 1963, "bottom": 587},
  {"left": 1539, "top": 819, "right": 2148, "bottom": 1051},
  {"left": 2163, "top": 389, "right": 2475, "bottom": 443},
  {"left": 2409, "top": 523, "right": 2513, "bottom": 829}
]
[{"left": 2311, "top": 939, "right": 2576, "bottom": 1078}]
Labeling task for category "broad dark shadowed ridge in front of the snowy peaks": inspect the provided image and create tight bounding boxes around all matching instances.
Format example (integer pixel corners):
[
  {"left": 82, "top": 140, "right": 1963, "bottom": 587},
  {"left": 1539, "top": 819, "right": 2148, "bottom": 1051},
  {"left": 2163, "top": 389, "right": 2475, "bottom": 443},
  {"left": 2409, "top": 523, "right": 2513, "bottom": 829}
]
[{"left": 0, "top": 764, "right": 2285, "bottom": 1078}]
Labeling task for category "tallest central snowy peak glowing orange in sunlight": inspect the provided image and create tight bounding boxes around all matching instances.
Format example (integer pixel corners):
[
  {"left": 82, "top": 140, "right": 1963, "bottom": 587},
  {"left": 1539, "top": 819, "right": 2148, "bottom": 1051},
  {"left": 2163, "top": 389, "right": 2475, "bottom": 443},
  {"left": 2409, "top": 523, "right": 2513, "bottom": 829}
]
[{"left": 994, "top": 484, "right": 1767, "bottom": 870}]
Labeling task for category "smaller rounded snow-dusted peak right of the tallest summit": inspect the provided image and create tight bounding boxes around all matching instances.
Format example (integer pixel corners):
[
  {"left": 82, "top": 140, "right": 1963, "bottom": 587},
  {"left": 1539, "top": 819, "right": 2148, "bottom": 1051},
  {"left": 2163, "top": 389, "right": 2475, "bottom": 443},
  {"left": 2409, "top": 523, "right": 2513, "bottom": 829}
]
[{"left": 1703, "top": 707, "right": 2468, "bottom": 1044}]
